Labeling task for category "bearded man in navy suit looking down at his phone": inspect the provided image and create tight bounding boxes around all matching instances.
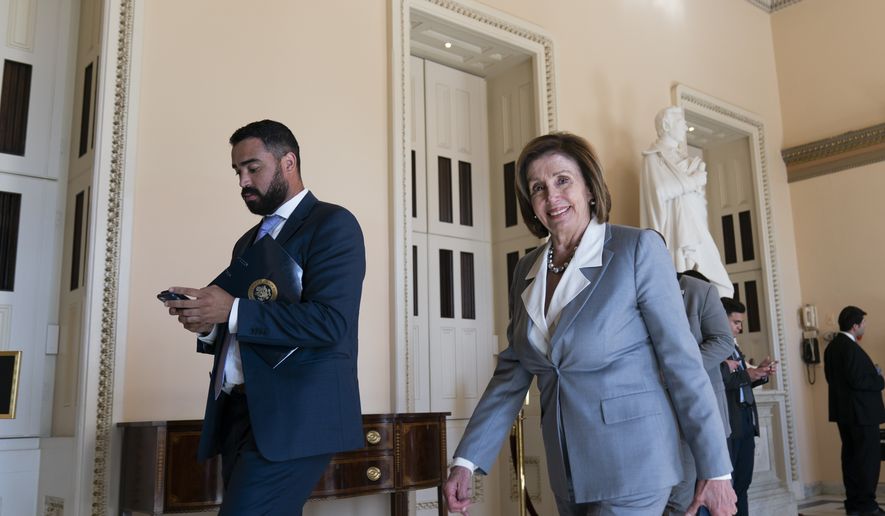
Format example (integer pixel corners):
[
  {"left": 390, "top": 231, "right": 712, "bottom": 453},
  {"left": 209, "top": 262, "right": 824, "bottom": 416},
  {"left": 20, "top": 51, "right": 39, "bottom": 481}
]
[{"left": 167, "top": 120, "right": 366, "bottom": 516}]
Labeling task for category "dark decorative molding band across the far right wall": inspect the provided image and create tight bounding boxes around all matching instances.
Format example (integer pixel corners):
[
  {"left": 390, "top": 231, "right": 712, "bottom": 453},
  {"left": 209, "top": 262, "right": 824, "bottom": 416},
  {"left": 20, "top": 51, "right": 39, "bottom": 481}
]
[{"left": 781, "top": 123, "right": 885, "bottom": 183}]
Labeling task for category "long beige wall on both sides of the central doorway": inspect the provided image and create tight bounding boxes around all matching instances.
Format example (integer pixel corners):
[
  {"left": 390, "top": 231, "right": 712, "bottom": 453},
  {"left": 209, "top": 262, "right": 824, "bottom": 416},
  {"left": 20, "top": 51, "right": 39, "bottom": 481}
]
[{"left": 123, "top": 0, "right": 812, "bottom": 492}]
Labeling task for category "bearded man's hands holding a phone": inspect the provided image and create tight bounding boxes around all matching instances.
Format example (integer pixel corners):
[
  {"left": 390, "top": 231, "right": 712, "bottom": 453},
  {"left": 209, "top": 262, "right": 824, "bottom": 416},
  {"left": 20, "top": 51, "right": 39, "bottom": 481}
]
[{"left": 157, "top": 285, "right": 234, "bottom": 333}]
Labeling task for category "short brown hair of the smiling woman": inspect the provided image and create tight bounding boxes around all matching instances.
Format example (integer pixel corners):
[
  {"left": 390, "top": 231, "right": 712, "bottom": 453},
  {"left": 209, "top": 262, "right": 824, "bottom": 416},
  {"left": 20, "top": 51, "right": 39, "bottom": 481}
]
[{"left": 516, "top": 132, "right": 611, "bottom": 238}]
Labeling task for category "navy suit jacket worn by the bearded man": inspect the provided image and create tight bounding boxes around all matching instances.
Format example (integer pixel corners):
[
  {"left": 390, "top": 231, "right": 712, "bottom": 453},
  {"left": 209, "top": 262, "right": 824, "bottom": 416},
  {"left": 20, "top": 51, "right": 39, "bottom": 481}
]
[{"left": 197, "top": 192, "right": 366, "bottom": 461}]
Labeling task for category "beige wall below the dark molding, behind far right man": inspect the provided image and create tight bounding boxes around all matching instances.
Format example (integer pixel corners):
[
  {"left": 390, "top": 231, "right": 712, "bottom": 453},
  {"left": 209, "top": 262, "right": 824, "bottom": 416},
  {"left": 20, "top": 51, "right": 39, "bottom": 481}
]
[{"left": 790, "top": 163, "right": 885, "bottom": 485}]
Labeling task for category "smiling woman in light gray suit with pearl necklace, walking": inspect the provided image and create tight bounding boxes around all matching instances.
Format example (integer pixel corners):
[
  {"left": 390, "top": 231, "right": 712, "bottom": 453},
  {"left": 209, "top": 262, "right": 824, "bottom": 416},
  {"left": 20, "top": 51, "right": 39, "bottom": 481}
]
[{"left": 445, "top": 133, "right": 735, "bottom": 516}]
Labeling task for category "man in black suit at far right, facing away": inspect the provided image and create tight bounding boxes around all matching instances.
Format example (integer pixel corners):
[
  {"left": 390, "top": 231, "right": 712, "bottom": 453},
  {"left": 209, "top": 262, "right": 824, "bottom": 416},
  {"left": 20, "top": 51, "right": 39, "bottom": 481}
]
[{"left": 824, "top": 306, "right": 885, "bottom": 515}]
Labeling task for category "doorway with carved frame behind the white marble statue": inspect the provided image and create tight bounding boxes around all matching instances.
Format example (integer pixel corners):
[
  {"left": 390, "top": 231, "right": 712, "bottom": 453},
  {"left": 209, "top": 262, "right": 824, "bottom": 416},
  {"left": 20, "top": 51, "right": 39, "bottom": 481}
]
[{"left": 674, "top": 85, "right": 801, "bottom": 515}]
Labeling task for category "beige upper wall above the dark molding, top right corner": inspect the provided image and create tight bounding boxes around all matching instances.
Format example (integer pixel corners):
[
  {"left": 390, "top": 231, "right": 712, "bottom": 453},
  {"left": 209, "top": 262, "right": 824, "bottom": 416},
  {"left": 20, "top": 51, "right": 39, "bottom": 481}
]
[{"left": 771, "top": 0, "right": 885, "bottom": 147}]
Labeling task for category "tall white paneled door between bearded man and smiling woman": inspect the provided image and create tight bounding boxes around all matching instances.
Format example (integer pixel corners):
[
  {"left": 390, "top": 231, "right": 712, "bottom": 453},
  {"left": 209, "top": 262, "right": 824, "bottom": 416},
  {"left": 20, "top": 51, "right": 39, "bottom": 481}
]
[{"left": 409, "top": 57, "right": 498, "bottom": 516}]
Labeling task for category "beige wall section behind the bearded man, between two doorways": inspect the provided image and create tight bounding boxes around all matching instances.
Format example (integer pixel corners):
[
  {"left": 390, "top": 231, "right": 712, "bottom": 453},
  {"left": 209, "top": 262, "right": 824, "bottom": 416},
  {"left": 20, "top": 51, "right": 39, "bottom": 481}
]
[{"left": 122, "top": 0, "right": 391, "bottom": 420}]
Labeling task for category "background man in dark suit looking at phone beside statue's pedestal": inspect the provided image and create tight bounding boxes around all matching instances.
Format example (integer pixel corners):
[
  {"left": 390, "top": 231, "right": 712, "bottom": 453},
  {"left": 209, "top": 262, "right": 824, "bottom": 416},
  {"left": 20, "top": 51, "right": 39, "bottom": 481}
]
[{"left": 721, "top": 297, "right": 777, "bottom": 516}]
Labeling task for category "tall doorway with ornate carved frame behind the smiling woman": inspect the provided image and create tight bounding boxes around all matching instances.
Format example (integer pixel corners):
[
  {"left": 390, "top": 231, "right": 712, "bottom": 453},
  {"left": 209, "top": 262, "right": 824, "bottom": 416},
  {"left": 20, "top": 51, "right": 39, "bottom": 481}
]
[{"left": 392, "top": 0, "right": 555, "bottom": 514}]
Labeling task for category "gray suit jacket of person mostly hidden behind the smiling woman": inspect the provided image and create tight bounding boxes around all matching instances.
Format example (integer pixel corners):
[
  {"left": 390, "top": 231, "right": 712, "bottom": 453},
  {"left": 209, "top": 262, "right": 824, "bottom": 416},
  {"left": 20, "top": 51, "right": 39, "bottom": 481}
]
[{"left": 679, "top": 276, "right": 734, "bottom": 437}]
